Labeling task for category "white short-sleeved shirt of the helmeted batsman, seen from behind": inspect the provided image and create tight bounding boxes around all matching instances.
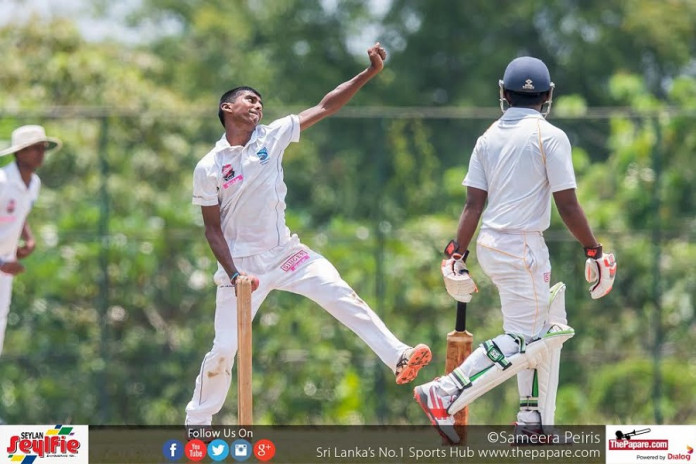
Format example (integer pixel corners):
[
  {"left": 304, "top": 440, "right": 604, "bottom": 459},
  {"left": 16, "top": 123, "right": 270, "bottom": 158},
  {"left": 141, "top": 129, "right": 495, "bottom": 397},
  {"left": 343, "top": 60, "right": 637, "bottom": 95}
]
[{"left": 462, "top": 107, "right": 577, "bottom": 232}]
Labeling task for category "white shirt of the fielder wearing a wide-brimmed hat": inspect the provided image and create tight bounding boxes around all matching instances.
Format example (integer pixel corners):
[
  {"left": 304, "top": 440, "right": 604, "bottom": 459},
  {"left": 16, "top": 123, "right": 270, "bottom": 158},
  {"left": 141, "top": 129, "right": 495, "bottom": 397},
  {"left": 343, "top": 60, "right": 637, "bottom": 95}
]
[{"left": 0, "top": 161, "right": 41, "bottom": 261}]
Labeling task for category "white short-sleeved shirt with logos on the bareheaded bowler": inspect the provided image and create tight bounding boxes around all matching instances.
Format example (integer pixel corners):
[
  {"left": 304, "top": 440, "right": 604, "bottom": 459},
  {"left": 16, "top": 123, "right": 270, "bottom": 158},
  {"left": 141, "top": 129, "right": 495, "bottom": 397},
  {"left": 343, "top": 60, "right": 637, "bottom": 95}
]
[{"left": 193, "top": 115, "right": 300, "bottom": 258}]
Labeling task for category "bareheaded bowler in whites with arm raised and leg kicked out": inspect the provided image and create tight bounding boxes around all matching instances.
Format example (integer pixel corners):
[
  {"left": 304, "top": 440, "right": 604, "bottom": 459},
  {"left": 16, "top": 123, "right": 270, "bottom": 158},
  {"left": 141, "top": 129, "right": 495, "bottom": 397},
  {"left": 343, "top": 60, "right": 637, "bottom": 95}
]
[{"left": 186, "top": 44, "right": 431, "bottom": 425}]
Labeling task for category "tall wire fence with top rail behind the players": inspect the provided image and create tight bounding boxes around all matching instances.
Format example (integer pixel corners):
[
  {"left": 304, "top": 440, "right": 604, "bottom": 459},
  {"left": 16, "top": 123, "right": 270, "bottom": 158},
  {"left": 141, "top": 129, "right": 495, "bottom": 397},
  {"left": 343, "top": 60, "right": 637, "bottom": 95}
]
[{"left": 0, "top": 108, "right": 696, "bottom": 424}]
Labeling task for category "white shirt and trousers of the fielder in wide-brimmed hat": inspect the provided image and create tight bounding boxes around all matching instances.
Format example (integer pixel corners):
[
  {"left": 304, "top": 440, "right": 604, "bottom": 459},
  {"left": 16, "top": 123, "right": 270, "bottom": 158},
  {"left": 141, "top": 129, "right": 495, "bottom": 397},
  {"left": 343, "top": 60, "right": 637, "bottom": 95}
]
[{"left": 0, "top": 162, "right": 41, "bottom": 353}]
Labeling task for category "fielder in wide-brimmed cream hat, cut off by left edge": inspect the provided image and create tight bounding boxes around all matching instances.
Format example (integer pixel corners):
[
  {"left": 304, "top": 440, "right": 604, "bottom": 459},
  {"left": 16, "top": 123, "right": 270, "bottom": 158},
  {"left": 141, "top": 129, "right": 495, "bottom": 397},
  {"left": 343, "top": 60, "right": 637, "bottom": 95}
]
[{"left": 0, "top": 126, "right": 61, "bottom": 353}]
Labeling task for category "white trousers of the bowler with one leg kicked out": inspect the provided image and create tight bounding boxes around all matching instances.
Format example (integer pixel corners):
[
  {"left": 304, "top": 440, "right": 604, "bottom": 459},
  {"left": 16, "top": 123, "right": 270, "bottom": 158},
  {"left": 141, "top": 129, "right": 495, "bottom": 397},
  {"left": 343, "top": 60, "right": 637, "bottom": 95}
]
[{"left": 186, "top": 235, "right": 409, "bottom": 425}]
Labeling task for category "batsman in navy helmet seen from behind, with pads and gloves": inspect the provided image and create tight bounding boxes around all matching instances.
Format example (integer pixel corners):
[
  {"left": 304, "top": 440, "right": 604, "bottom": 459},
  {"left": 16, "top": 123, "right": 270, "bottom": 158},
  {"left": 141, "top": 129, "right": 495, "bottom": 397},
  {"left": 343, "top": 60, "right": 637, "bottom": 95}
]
[{"left": 414, "top": 57, "right": 616, "bottom": 443}]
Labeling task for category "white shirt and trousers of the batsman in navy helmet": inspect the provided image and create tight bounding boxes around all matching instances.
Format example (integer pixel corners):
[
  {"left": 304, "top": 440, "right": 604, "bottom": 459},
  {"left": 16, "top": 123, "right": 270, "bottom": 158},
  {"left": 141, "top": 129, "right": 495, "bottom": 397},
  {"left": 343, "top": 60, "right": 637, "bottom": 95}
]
[{"left": 463, "top": 107, "right": 576, "bottom": 338}]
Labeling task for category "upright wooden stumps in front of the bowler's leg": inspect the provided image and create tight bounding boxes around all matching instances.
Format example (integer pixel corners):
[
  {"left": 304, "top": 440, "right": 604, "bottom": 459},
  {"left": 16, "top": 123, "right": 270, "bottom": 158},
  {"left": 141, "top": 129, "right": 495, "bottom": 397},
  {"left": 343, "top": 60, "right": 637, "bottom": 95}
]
[{"left": 236, "top": 276, "right": 254, "bottom": 425}]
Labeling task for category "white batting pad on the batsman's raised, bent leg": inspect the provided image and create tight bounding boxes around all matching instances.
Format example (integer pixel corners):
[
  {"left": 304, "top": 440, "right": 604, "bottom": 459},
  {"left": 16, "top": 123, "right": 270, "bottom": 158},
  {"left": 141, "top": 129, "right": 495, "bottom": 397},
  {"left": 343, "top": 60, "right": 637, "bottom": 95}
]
[{"left": 447, "top": 324, "right": 575, "bottom": 415}]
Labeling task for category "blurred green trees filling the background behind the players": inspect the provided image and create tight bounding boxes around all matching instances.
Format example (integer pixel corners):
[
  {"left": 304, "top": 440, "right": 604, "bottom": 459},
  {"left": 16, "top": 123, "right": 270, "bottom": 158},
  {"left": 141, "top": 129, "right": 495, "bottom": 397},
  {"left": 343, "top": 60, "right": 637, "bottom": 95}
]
[{"left": 0, "top": 0, "right": 696, "bottom": 424}]
